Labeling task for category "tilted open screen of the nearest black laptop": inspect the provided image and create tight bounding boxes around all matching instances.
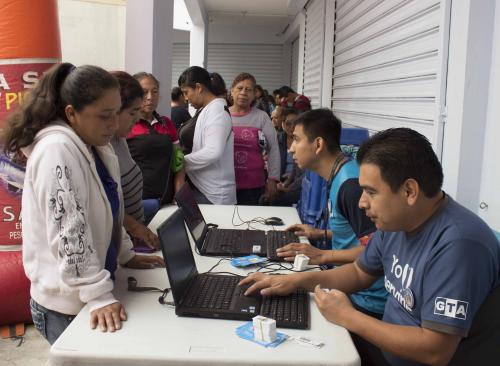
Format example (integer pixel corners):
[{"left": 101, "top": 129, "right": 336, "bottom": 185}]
[{"left": 158, "top": 210, "right": 198, "bottom": 304}]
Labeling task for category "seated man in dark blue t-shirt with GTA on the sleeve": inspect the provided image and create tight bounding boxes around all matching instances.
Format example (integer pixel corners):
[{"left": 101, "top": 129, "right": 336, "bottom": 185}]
[{"left": 242, "top": 128, "right": 500, "bottom": 366}]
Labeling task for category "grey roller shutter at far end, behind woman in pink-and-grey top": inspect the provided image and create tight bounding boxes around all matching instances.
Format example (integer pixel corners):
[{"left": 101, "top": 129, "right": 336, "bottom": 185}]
[{"left": 207, "top": 43, "right": 285, "bottom": 93}]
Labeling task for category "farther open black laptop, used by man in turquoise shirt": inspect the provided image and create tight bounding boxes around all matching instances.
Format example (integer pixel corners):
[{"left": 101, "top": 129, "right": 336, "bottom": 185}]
[{"left": 175, "top": 184, "right": 299, "bottom": 261}]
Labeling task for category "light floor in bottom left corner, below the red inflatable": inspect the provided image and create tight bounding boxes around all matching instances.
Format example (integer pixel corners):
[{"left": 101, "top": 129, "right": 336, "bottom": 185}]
[{"left": 0, "top": 324, "right": 50, "bottom": 366}]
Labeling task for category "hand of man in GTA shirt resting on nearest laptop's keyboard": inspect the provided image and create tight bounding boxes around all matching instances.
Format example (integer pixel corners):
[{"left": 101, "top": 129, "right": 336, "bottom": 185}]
[{"left": 238, "top": 273, "right": 297, "bottom": 296}]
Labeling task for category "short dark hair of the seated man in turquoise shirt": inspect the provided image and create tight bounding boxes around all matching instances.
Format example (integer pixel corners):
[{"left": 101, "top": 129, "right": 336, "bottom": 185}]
[{"left": 294, "top": 108, "right": 342, "bottom": 154}]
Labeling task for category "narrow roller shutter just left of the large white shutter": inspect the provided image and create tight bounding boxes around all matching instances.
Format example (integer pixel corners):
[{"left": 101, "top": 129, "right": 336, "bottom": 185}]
[{"left": 302, "top": 0, "right": 325, "bottom": 108}]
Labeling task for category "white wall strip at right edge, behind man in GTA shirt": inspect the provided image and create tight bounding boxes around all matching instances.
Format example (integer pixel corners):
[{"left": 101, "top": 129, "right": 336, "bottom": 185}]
[{"left": 479, "top": 0, "right": 500, "bottom": 231}]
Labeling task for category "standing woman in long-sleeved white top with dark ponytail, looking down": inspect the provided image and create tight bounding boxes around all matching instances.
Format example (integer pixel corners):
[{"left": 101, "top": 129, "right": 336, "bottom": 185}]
[{"left": 179, "top": 66, "right": 236, "bottom": 205}]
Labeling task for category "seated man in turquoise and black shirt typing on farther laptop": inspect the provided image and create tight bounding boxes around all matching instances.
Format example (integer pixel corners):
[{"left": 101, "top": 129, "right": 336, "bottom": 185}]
[{"left": 272, "top": 109, "right": 387, "bottom": 349}]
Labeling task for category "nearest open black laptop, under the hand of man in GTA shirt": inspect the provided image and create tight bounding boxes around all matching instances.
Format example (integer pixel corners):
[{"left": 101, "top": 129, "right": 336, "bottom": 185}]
[{"left": 158, "top": 210, "right": 309, "bottom": 329}]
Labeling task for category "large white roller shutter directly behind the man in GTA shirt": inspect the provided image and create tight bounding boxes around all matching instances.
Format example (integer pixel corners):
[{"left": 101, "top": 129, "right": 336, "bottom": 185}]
[{"left": 331, "top": 0, "right": 449, "bottom": 152}]
